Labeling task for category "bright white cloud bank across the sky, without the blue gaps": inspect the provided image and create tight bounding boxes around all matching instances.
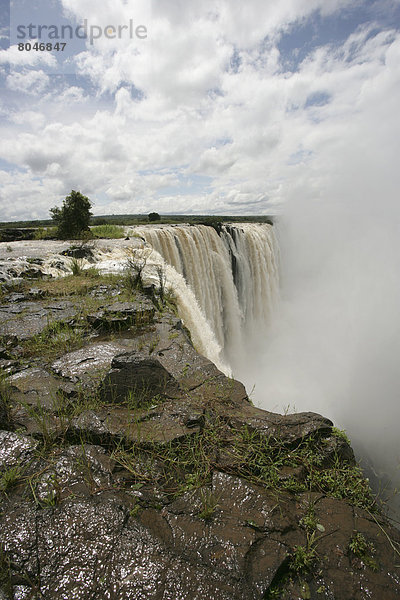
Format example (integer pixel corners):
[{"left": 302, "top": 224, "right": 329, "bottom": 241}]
[{"left": 0, "top": 0, "right": 400, "bottom": 220}]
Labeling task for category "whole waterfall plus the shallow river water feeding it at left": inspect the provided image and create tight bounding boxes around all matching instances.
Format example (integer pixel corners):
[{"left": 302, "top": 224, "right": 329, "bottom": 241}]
[{"left": 0, "top": 223, "right": 279, "bottom": 375}]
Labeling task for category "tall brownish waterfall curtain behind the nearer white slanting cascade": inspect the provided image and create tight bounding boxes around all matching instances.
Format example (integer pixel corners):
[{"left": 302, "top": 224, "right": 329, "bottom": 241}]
[{"left": 134, "top": 223, "right": 279, "bottom": 366}]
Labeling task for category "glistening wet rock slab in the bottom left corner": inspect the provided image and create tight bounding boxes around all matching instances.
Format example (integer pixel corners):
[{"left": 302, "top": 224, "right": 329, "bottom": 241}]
[{"left": 2, "top": 497, "right": 247, "bottom": 600}]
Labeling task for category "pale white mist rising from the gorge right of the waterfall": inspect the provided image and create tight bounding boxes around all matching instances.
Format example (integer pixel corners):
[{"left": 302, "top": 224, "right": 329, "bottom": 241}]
[{"left": 235, "top": 190, "right": 400, "bottom": 506}]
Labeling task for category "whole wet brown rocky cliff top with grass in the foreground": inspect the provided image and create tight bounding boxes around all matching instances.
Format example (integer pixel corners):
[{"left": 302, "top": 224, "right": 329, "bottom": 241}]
[{"left": 0, "top": 272, "right": 400, "bottom": 600}]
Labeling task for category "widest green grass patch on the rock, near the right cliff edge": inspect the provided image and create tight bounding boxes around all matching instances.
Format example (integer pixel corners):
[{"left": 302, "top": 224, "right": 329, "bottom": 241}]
[{"left": 105, "top": 414, "right": 375, "bottom": 510}]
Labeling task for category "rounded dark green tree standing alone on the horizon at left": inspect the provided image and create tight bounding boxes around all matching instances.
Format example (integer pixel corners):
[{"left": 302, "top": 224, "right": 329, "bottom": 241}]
[{"left": 50, "top": 190, "right": 92, "bottom": 240}]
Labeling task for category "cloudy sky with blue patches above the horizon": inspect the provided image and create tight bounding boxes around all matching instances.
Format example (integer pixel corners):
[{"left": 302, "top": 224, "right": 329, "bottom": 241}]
[{"left": 0, "top": 0, "right": 400, "bottom": 221}]
